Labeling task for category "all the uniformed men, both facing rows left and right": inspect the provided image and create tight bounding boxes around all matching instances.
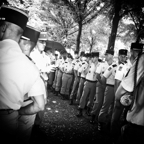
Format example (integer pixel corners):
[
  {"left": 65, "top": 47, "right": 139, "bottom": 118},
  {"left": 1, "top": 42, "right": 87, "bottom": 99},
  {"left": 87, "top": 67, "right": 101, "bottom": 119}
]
[{"left": 0, "top": 5, "right": 144, "bottom": 144}]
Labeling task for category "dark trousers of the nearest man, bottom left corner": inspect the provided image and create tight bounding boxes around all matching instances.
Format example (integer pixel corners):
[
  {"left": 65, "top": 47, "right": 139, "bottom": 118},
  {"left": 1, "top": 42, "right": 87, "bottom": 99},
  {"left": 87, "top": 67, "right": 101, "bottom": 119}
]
[{"left": 0, "top": 110, "right": 19, "bottom": 143}]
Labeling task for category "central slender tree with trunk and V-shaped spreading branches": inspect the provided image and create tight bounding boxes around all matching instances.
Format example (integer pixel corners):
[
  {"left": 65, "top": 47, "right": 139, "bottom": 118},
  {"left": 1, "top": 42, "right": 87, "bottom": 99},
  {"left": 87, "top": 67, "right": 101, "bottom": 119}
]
[{"left": 51, "top": 0, "right": 106, "bottom": 51}]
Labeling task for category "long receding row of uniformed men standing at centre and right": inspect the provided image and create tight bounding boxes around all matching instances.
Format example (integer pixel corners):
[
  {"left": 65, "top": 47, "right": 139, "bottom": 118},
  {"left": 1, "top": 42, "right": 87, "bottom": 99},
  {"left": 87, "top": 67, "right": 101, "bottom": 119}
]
[{"left": 53, "top": 43, "right": 135, "bottom": 127}]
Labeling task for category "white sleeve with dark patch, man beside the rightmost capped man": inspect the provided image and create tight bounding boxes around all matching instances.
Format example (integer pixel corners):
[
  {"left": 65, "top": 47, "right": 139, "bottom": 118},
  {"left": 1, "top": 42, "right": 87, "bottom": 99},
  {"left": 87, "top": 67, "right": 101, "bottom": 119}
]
[{"left": 115, "top": 65, "right": 124, "bottom": 81}]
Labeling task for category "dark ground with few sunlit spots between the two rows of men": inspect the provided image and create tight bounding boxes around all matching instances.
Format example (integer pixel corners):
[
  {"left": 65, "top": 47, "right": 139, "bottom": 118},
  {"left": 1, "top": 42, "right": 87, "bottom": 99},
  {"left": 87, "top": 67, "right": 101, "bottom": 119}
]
[{"left": 30, "top": 93, "right": 111, "bottom": 144}]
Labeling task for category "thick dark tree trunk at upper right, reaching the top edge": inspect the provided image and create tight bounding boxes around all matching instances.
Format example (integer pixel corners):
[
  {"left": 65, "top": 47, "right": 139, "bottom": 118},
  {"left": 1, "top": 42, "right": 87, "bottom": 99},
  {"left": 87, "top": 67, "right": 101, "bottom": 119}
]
[{"left": 107, "top": 0, "right": 121, "bottom": 50}]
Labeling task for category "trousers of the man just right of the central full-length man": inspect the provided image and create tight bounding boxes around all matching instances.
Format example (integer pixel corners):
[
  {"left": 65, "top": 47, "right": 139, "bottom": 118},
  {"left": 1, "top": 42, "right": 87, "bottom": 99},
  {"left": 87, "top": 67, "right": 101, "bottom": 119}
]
[{"left": 91, "top": 82, "right": 105, "bottom": 120}]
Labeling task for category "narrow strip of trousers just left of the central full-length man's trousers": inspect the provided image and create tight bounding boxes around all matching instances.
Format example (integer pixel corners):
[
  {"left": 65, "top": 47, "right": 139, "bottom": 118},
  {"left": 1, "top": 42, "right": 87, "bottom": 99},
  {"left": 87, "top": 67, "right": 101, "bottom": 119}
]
[{"left": 76, "top": 77, "right": 85, "bottom": 103}]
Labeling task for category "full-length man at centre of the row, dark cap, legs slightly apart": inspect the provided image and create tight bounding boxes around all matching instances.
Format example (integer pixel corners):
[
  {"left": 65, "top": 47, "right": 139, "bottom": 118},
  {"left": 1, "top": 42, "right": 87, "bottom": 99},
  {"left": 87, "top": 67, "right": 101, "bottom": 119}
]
[{"left": 77, "top": 52, "right": 99, "bottom": 117}]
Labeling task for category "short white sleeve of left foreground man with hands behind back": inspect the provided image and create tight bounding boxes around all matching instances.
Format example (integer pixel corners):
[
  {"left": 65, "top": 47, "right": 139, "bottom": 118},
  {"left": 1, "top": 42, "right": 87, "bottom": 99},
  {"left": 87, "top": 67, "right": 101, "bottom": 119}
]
[{"left": 28, "top": 77, "right": 46, "bottom": 97}]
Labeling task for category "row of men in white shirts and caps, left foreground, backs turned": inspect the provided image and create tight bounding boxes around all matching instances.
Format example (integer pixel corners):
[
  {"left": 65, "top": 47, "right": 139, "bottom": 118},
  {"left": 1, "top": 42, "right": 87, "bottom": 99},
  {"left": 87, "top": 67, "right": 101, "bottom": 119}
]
[{"left": 0, "top": 6, "right": 53, "bottom": 144}]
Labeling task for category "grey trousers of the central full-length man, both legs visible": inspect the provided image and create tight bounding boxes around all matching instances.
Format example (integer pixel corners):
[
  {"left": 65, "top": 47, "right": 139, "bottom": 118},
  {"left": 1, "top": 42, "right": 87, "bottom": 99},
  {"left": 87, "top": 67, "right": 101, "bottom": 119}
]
[{"left": 79, "top": 80, "right": 96, "bottom": 109}]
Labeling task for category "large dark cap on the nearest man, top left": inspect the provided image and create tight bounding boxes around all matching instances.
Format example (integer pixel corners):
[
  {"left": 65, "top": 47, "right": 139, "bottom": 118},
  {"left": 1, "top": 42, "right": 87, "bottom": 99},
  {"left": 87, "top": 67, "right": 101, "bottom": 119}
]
[{"left": 0, "top": 5, "right": 28, "bottom": 30}]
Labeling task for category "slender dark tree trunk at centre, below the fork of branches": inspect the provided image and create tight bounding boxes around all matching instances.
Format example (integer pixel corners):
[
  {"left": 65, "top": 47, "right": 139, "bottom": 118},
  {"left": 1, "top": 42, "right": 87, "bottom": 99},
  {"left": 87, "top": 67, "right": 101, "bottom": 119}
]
[{"left": 76, "top": 21, "right": 82, "bottom": 53}]
